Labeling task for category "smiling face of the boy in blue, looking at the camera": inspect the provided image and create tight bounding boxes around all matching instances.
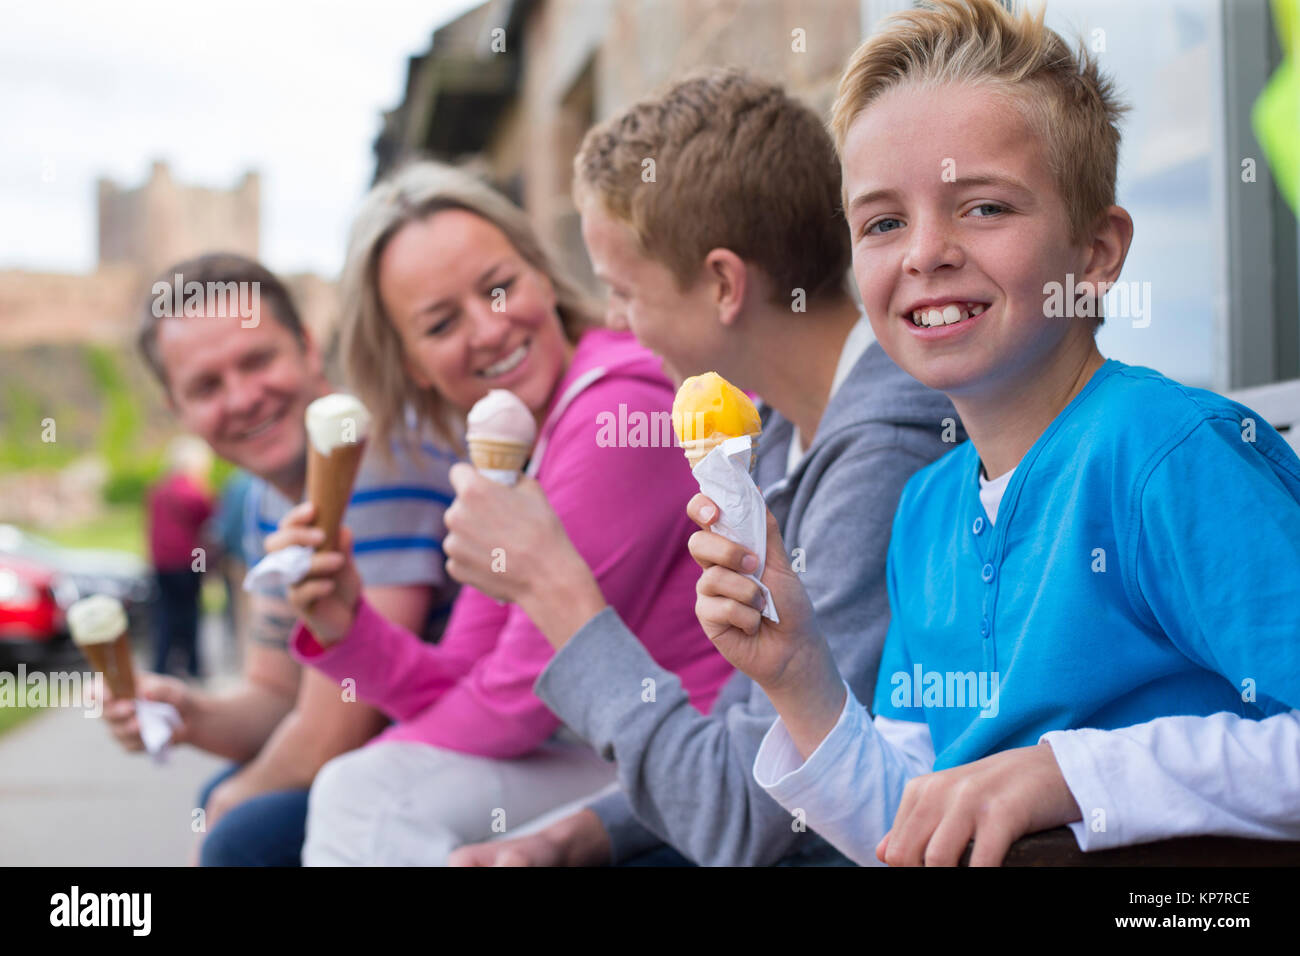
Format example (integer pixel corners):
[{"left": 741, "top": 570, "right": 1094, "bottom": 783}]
[{"left": 842, "top": 85, "right": 1092, "bottom": 398}]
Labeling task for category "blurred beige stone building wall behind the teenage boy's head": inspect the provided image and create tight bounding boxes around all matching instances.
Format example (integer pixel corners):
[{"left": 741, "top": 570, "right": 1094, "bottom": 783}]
[{"left": 506, "top": 0, "right": 863, "bottom": 282}]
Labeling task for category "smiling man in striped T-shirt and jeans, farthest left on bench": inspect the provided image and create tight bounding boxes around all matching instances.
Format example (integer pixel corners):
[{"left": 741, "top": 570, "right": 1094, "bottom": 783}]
[{"left": 104, "top": 254, "right": 454, "bottom": 865}]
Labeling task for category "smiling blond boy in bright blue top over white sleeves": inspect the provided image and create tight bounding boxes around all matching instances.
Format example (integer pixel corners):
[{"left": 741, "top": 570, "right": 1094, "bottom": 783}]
[{"left": 690, "top": 0, "right": 1300, "bottom": 865}]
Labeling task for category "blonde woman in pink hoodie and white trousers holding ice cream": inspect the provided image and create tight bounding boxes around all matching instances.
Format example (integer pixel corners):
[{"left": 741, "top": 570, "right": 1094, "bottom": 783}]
[{"left": 267, "top": 163, "right": 732, "bottom": 866}]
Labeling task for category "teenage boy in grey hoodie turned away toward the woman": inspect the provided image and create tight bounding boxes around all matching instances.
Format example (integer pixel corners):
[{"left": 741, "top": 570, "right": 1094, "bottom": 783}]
[{"left": 446, "top": 70, "right": 962, "bottom": 865}]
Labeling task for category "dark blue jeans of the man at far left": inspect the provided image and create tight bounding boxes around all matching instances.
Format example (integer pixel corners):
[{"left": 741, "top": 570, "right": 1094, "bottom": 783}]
[{"left": 199, "top": 763, "right": 307, "bottom": 866}]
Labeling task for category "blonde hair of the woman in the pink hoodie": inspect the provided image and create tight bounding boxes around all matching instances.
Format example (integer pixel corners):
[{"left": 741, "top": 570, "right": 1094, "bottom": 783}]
[{"left": 339, "top": 160, "right": 595, "bottom": 455}]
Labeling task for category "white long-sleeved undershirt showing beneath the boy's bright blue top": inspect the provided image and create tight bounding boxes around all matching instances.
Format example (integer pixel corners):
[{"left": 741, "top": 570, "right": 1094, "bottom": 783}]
[{"left": 754, "top": 472, "right": 1300, "bottom": 866}]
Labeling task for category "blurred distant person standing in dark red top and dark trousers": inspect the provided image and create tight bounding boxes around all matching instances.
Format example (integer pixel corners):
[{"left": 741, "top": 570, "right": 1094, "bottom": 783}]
[{"left": 146, "top": 436, "right": 213, "bottom": 678}]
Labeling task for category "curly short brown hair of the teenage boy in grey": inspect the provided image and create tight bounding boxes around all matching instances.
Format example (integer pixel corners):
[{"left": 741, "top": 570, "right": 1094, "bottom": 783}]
[{"left": 573, "top": 68, "right": 850, "bottom": 302}]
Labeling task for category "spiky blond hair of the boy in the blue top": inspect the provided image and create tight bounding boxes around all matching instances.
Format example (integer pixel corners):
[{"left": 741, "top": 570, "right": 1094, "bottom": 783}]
[{"left": 831, "top": 0, "right": 1127, "bottom": 242}]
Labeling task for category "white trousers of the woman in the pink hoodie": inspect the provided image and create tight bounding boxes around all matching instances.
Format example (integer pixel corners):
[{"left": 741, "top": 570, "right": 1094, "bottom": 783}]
[{"left": 303, "top": 732, "right": 615, "bottom": 866}]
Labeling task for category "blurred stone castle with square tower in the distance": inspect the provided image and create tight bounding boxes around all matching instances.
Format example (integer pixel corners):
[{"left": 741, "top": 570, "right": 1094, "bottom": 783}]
[{"left": 0, "top": 161, "right": 338, "bottom": 349}]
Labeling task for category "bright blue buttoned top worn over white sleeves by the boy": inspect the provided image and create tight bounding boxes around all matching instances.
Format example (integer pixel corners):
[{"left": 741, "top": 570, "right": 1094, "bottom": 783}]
[{"left": 874, "top": 362, "right": 1300, "bottom": 770}]
